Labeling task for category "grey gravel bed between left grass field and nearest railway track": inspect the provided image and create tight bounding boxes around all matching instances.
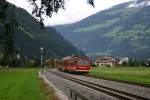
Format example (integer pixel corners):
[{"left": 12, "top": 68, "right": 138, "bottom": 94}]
[{"left": 41, "top": 71, "right": 117, "bottom": 100}]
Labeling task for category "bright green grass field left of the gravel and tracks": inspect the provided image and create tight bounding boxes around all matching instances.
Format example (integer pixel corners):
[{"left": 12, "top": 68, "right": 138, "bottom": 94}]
[{"left": 0, "top": 69, "right": 55, "bottom": 100}]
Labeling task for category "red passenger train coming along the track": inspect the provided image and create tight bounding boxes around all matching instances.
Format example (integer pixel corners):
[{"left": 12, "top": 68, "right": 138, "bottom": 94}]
[{"left": 58, "top": 56, "right": 91, "bottom": 72}]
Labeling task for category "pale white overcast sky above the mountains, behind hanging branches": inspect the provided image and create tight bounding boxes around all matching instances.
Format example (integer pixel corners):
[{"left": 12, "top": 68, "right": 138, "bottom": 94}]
[{"left": 7, "top": 0, "right": 131, "bottom": 25}]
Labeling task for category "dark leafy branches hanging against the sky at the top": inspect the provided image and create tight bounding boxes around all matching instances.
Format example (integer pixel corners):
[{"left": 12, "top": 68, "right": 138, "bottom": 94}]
[{"left": 28, "top": 0, "right": 94, "bottom": 26}]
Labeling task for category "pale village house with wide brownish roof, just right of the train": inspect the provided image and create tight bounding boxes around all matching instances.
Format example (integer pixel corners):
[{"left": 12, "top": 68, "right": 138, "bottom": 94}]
[{"left": 95, "top": 56, "right": 116, "bottom": 67}]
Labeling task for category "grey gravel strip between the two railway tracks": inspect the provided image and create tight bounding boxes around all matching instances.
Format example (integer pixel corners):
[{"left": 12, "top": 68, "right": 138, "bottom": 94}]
[{"left": 53, "top": 69, "right": 150, "bottom": 99}]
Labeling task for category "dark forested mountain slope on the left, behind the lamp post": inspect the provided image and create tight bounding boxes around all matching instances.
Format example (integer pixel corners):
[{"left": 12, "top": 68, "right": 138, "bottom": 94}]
[{"left": 0, "top": 4, "right": 79, "bottom": 58}]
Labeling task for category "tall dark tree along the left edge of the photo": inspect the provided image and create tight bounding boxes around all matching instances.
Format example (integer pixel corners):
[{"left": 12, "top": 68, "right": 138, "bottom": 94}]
[{"left": 0, "top": 0, "right": 18, "bottom": 66}]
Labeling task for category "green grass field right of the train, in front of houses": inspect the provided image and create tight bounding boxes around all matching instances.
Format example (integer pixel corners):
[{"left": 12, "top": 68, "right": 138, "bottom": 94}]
[{"left": 89, "top": 67, "right": 150, "bottom": 85}]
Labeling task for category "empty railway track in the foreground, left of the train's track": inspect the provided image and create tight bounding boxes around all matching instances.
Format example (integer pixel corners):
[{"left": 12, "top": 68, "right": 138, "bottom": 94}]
[{"left": 48, "top": 70, "right": 150, "bottom": 100}]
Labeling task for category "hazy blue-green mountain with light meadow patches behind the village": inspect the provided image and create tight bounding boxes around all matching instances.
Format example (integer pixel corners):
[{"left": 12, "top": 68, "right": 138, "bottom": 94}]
[{"left": 54, "top": 0, "right": 150, "bottom": 59}]
